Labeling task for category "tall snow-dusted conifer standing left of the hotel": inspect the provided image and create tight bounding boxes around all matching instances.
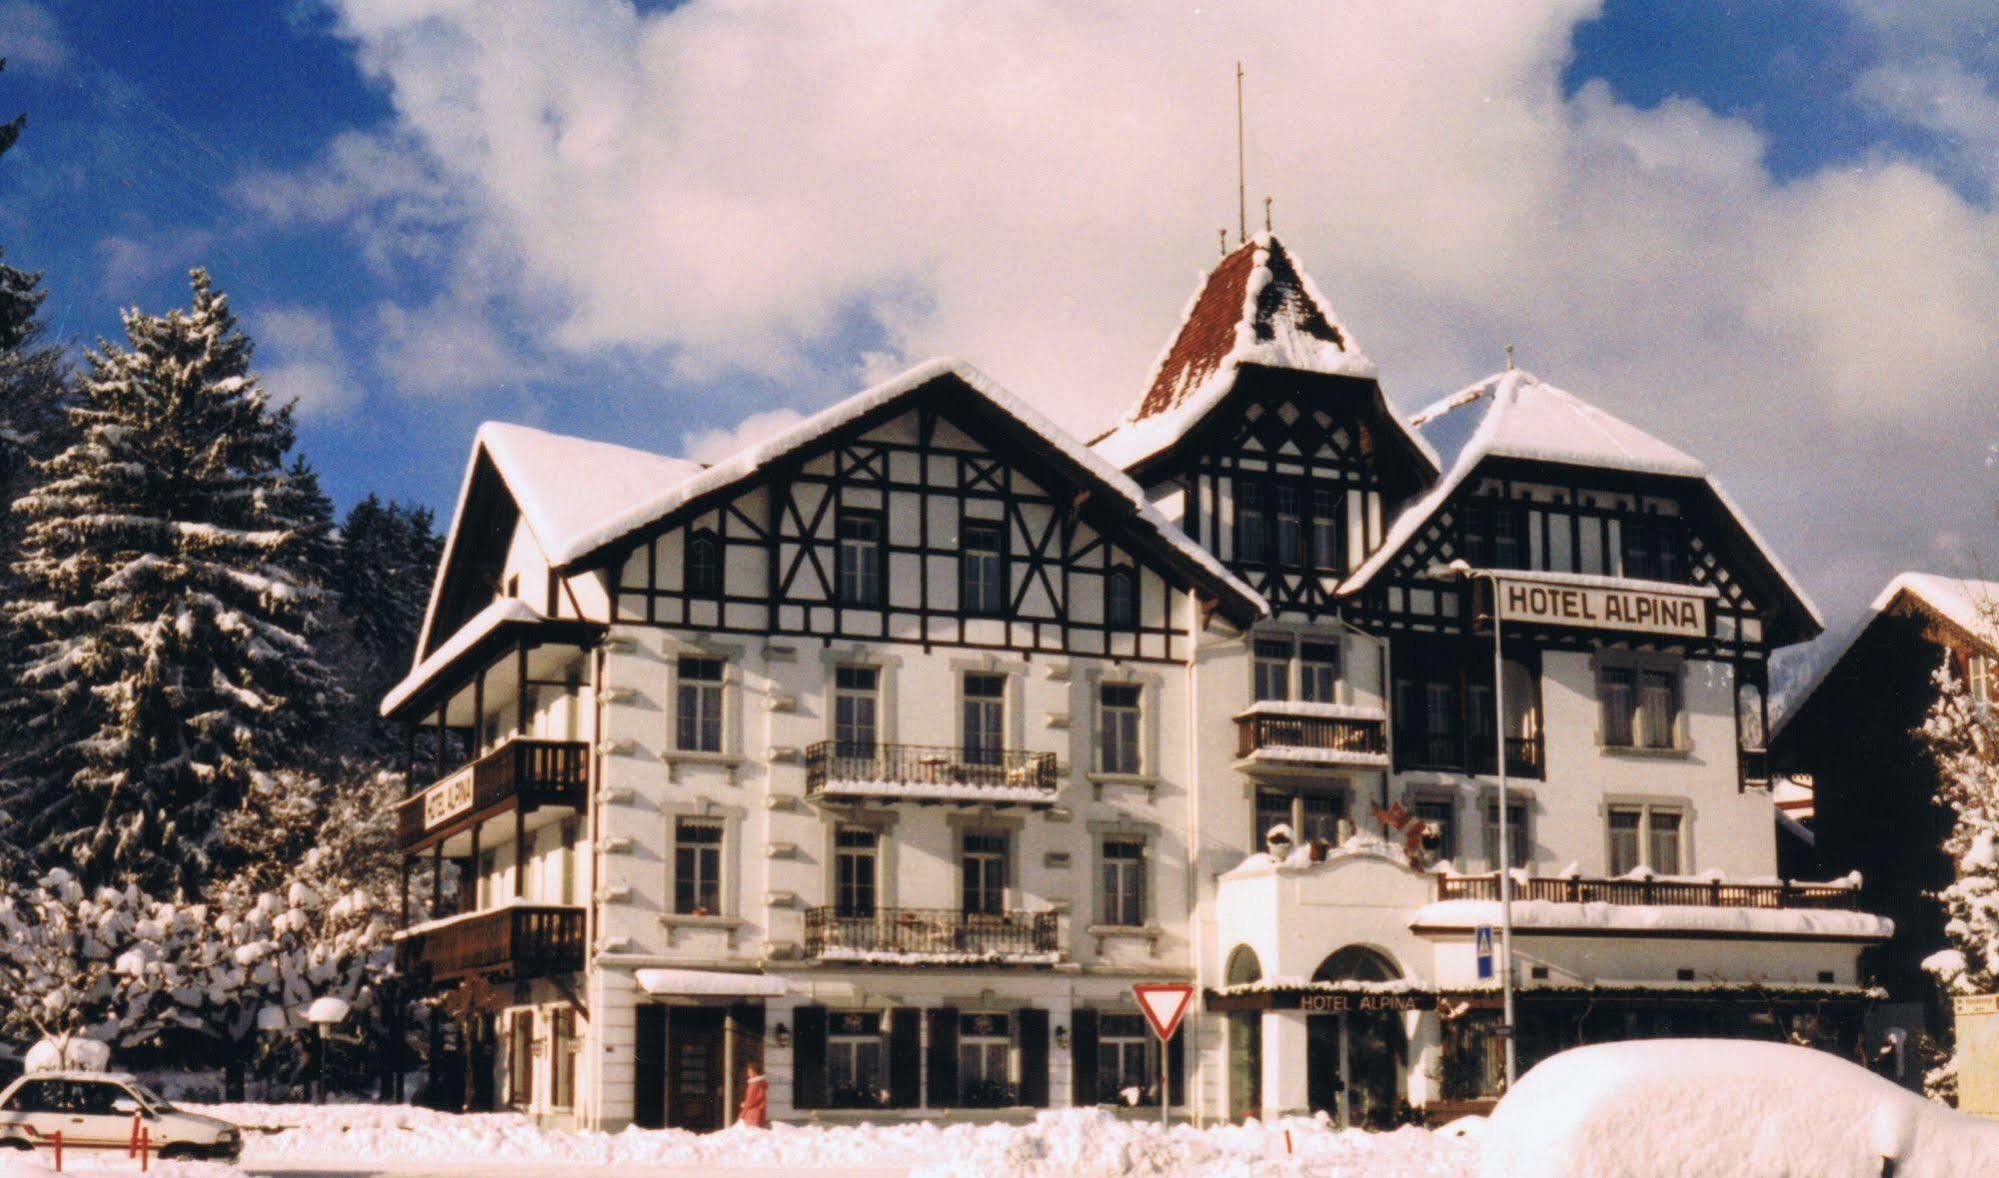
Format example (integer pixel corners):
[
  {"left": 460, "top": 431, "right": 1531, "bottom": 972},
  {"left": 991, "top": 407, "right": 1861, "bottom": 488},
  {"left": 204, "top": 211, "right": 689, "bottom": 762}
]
[{"left": 4, "top": 270, "right": 334, "bottom": 894}]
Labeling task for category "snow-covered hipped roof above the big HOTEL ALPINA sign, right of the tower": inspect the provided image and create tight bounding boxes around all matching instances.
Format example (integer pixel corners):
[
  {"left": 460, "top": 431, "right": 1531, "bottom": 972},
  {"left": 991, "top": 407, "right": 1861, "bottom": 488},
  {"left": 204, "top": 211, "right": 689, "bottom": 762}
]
[{"left": 1339, "top": 368, "right": 1825, "bottom": 628}]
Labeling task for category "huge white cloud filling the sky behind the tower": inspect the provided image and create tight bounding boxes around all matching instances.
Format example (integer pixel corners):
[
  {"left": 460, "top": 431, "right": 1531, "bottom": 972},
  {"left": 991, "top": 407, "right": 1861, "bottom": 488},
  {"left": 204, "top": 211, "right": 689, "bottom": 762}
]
[{"left": 291, "top": 0, "right": 1999, "bottom": 624}]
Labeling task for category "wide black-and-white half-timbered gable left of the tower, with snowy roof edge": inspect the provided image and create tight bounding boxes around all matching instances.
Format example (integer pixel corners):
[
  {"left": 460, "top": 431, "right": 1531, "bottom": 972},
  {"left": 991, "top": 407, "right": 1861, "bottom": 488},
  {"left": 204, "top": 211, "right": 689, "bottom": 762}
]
[{"left": 559, "top": 358, "right": 1259, "bottom": 660}]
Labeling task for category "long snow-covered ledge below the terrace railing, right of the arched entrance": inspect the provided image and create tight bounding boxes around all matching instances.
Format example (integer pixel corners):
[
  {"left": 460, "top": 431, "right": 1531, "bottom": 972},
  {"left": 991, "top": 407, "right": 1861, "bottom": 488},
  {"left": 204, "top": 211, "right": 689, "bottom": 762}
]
[{"left": 1409, "top": 900, "right": 1895, "bottom": 940}]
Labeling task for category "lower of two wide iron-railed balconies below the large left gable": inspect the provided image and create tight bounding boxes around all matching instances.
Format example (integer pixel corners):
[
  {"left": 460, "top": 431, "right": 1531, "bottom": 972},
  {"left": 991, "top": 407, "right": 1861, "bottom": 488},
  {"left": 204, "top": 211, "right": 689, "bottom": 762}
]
[{"left": 806, "top": 908, "right": 1061, "bottom": 966}]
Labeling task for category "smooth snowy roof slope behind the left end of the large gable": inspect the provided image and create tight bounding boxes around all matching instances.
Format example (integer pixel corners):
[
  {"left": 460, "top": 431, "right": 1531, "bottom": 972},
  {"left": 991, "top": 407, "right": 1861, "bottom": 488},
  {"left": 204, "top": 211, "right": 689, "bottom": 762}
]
[{"left": 474, "top": 422, "right": 702, "bottom": 564}]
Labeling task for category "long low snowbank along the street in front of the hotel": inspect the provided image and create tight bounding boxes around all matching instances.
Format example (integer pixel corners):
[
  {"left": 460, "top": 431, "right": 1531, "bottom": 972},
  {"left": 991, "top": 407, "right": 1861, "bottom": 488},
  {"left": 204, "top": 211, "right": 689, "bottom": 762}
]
[{"left": 202, "top": 1104, "right": 1477, "bottom": 1178}]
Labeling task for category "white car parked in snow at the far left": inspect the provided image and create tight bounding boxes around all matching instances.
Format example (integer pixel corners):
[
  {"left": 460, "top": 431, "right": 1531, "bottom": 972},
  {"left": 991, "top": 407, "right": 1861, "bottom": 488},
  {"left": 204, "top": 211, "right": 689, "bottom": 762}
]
[{"left": 0, "top": 1072, "right": 244, "bottom": 1162}]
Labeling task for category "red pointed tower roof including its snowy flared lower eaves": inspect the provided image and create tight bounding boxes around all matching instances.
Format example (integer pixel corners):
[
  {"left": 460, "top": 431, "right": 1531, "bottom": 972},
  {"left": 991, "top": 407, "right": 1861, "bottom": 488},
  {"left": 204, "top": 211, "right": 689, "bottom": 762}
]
[{"left": 1093, "top": 232, "right": 1437, "bottom": 470}]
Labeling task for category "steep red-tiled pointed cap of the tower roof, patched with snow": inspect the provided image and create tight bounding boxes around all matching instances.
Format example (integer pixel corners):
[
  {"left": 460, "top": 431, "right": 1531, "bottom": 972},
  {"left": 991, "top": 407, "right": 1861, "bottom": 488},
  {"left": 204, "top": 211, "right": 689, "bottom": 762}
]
[{"left": 1125, "top": 232, "right": 1375, "bottom": 422}]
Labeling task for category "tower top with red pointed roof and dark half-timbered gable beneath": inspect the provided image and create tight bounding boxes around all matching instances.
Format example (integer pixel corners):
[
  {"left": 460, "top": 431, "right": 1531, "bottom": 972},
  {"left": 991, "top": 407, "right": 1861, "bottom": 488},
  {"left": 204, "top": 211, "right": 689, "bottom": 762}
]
[{"left": 1095, "top": 234, "right": 1437, "bottom": 620}]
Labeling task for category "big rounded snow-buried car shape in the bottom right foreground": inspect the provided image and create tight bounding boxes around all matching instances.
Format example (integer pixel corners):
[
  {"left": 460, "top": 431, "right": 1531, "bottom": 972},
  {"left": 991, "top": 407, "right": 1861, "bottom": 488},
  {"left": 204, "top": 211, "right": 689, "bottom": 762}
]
[{"left": 1479, "top": 1040, "right": 1999, "bottom": 1178}]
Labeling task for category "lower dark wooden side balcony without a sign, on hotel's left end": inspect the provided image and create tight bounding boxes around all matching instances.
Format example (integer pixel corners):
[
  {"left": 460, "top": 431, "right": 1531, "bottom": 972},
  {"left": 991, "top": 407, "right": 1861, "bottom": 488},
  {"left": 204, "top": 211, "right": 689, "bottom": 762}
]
[{"left": 396, "top": 904, "right": 584, "bottom": 982}]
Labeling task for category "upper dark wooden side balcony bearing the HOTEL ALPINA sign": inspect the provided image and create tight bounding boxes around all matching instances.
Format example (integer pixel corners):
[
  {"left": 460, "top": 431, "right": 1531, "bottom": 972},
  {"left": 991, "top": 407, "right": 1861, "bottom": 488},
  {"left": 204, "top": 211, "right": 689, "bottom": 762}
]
[{"left": 396, "top": 738, "right": 590, "bottom": 854}]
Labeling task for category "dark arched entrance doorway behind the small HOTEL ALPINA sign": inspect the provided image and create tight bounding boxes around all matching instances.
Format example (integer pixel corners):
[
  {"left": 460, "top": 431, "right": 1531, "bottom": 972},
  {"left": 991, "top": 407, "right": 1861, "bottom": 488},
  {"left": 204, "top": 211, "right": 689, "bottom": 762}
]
[{"left": 1305, "top": 944, "right": 1409, "bottom": 1128}]
